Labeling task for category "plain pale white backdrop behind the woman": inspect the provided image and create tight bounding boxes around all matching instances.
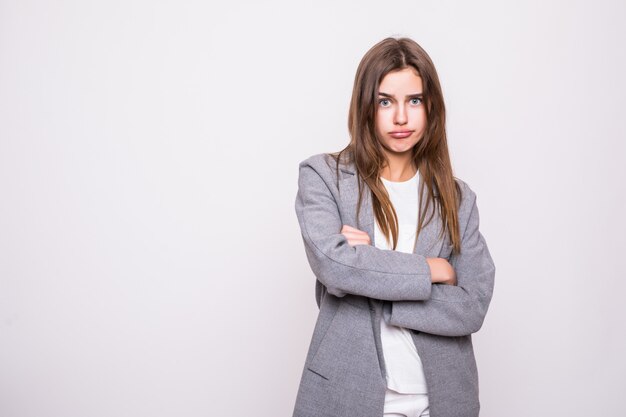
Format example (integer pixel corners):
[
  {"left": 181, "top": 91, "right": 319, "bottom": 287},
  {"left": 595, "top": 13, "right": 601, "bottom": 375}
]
[{"left": 0, "top": 0, "right": 626, "bottom": 417}]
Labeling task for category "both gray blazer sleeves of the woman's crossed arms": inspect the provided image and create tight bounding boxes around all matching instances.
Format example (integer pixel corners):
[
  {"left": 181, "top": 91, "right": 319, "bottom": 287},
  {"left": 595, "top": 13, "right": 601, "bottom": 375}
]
[{"left": 295, "top": 157, "right": 495, "bottom": 336}]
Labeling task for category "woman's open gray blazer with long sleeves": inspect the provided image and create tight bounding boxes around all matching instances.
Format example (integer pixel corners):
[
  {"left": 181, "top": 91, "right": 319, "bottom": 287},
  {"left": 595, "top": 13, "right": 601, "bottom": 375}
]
[{"left": 293, "top": 154, "right": 495, "bottom": 417}]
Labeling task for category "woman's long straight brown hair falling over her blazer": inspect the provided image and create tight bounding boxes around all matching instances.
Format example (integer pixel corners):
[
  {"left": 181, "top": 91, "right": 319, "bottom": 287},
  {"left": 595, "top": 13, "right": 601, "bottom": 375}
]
[{"left": 330, "top": 38, "right": 461, "bottom": 253}]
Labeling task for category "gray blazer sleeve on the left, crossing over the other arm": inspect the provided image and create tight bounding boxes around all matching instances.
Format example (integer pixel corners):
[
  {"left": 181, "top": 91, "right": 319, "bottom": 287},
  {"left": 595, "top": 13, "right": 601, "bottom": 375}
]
[{"left": 295, "top": 158, "right": 432, "bottom": 301}]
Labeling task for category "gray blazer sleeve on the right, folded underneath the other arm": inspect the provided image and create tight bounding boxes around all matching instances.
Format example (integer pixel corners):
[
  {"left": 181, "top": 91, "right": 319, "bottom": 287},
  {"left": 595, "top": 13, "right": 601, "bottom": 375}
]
[{"left": 385, "top": 185, "right": 496, "bottom": 336}]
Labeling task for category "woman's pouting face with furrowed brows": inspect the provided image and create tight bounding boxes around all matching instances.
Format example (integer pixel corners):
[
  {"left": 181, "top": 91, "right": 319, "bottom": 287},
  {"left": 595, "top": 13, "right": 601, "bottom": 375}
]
[{"left": 376, "top": 67, "right": 426, "bottom": 160}]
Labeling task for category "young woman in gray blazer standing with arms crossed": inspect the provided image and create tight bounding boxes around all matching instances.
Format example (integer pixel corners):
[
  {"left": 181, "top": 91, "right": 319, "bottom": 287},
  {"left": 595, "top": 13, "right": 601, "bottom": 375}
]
[{"left": 293, "top": 38, "right": 495, "bottom": 417}]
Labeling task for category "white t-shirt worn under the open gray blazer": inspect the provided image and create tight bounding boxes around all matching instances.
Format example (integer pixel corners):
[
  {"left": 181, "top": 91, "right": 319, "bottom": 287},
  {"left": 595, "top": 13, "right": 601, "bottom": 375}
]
[{"left": 374, "top": 171, "right": 428, "bottom": 394}]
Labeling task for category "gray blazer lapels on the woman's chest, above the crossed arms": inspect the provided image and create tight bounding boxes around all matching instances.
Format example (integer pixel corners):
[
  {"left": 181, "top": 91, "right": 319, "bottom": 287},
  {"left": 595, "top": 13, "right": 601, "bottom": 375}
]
[{"left": 333, "top": 163, "right": 446, "bottom": 258}]
